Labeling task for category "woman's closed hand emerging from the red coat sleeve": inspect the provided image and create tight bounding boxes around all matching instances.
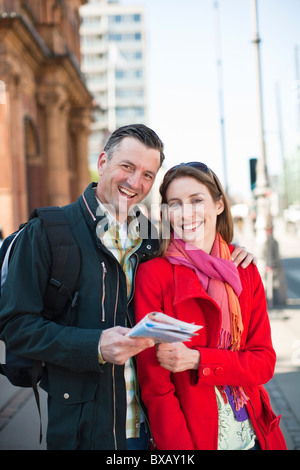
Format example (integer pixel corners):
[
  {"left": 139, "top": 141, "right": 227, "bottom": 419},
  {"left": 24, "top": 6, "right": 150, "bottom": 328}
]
[{"left": 156, "top": 343, "right": 200, "bottom": 372}]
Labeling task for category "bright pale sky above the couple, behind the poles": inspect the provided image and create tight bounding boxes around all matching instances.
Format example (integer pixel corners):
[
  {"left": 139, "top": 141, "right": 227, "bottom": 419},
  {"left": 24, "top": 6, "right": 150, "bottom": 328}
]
[{"left": 120, "top": 0, "right": 300, "bottom": 198}]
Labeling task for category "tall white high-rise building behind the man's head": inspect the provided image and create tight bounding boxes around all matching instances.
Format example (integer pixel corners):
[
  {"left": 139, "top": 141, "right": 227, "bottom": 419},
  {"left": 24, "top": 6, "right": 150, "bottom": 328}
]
[{"left": 80, "top": 0, "right": 148, "bottom": 164}]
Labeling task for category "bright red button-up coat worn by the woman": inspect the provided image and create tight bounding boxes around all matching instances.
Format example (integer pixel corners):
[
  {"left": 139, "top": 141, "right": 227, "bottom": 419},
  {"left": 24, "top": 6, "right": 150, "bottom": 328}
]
[{"left": 135, "top": 252, "right": 286, "bottom": 450}]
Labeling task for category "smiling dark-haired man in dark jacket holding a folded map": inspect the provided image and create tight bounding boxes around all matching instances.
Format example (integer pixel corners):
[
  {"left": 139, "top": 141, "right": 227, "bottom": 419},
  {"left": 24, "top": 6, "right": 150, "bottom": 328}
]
[{"left": 0, "top": 125, "right": 252, "bottom": 450}]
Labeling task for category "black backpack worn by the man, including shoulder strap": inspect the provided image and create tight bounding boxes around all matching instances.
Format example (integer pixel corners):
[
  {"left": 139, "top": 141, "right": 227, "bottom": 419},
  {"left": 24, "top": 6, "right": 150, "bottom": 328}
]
[{"left": 0, "top": 207, "right": 81, "bottom": 442}]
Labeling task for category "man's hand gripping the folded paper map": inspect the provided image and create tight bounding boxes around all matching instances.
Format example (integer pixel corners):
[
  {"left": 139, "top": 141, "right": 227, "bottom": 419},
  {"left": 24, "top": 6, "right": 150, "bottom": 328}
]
[{"left": 99, "top": 326, "right": 154, "bottom": 365}]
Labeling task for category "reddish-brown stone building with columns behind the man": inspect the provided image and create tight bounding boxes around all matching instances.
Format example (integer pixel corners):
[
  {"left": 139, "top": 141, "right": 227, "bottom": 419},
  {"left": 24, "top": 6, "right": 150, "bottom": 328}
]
[{"left": 0, "top": 0, "right": 93, "bottom": 236}]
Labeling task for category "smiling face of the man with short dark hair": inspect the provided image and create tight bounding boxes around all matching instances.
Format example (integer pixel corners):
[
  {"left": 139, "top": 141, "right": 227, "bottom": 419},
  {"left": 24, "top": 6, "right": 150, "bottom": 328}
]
[{"left": 96, "top": 137, "right": 160, "bottom": 223}]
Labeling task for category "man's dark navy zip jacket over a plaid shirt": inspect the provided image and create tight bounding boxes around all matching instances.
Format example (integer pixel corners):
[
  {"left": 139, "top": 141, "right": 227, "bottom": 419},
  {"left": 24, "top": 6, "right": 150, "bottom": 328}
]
[{"left": 0, "top": 184, "right": 158, "bottom": 450}]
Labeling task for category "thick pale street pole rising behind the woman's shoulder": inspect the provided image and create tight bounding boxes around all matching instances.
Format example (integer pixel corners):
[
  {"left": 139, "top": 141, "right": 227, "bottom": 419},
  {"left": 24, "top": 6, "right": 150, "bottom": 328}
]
[{"left": 252, "top": 0, "right": 285, "bottom": 307}]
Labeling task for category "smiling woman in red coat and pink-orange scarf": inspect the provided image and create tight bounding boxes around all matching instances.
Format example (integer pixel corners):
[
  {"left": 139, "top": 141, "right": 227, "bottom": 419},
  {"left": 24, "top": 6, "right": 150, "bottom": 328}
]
[{"left": 135, "top": 162, "right": 286, "bottom": 450}]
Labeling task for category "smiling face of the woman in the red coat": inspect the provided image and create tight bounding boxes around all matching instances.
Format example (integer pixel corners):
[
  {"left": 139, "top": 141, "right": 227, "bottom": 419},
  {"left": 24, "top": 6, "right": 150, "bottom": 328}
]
[{"left": 166, "top": 176, "right": 224, "bottom": 253}]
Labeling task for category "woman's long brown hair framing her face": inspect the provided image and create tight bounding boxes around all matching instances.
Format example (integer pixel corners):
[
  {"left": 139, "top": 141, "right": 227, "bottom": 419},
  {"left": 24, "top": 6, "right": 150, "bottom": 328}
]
[{"left": 159, "top": 162, "right": 233, "bottom": 256}]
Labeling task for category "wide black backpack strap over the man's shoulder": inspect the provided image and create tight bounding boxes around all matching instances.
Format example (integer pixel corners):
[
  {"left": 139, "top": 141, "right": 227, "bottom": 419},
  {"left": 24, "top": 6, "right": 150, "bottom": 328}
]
[{"left": 31, "top": 207, "right": 81, "bottom": 320}]
